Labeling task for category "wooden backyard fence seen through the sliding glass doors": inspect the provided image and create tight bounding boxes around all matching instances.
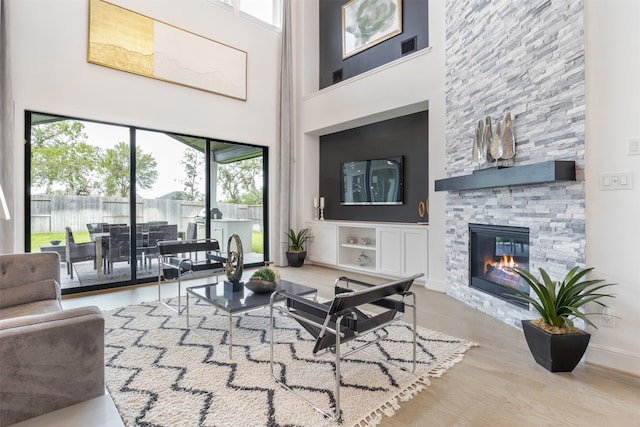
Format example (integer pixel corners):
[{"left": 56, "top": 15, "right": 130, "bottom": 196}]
[{"left": 31, "top": 195, "right": 263, "bottom": 233}]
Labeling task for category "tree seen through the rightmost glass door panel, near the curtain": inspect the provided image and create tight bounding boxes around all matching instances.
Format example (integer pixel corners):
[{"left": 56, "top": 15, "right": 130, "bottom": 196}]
[{"left": 218, "top": 157, "right": 262, "bottom": 205}]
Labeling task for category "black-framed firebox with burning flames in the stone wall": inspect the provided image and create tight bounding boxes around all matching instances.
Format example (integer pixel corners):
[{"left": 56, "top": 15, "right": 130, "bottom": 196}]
[{"left": 469, "top": 224, "right": 529, "bottom": 307}]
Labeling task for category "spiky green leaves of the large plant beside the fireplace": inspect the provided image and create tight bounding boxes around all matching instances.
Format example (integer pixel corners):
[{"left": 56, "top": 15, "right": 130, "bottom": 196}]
[{"left": 513, "top": 267, "right": 615, "bottom": 329}]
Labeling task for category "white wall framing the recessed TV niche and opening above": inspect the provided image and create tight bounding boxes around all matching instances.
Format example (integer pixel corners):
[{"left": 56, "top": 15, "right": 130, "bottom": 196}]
[{"left": 294, "top": 0, "right": 445, "bottom": 291}]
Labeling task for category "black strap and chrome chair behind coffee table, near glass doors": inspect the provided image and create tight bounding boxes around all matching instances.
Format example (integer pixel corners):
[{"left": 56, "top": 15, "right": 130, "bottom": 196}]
[{"left": 158, "top": 239, "right": 226, "bottom": 314}]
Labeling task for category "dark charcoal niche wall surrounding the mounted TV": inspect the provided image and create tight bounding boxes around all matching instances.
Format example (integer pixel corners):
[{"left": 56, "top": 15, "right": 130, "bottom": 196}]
[{"left": 319, "top": 111, "right": 429, "bottom": 222}]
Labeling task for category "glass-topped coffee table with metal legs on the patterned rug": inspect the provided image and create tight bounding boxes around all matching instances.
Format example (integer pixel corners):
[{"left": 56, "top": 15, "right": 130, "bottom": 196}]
[{"left": 186, "top": 280, "right": 318, "bottom": 359}]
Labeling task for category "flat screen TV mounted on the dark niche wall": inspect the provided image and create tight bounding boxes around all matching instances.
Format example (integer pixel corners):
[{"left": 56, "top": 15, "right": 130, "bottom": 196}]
[{"left": 340, "top": 156, "right": 404, "bottom": 205}]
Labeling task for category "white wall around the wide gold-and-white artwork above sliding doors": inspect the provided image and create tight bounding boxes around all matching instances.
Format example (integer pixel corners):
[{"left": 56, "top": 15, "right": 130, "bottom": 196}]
[{"left": 10, "top": 0, "right": 280, "bottom": 251}]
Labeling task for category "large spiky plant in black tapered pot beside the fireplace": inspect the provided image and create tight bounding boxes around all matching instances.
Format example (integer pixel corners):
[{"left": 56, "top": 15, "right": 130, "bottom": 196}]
[{"left": 512, "top": 267, "right": 614, "bottom": 372}]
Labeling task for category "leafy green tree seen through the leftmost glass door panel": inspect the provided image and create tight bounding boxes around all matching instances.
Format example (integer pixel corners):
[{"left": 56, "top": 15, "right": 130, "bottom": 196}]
[{"left": 31, "top": 120, "right": 102, "bottom": 196}]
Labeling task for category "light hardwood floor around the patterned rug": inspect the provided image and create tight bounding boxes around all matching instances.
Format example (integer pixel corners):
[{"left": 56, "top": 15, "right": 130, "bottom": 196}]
[{"left": 63, "top": 265, "right": 640, "bottom": 427}]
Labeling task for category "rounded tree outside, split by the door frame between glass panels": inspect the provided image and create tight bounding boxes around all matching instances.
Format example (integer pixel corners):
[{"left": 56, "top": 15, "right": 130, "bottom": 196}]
[{"left": 100, "top": 141, "right": 158, "bottom": 197}]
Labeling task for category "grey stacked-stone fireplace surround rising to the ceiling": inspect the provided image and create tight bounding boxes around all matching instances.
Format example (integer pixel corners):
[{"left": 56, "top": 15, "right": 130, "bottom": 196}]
[{"left": 437, "top": 0, "right": 586, "bottom": 328}]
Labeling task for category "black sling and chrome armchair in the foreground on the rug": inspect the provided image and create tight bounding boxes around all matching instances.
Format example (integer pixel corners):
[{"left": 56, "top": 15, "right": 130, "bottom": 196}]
[{"left": 270, "top": 273, "right": 423, "bottom": 421}]
